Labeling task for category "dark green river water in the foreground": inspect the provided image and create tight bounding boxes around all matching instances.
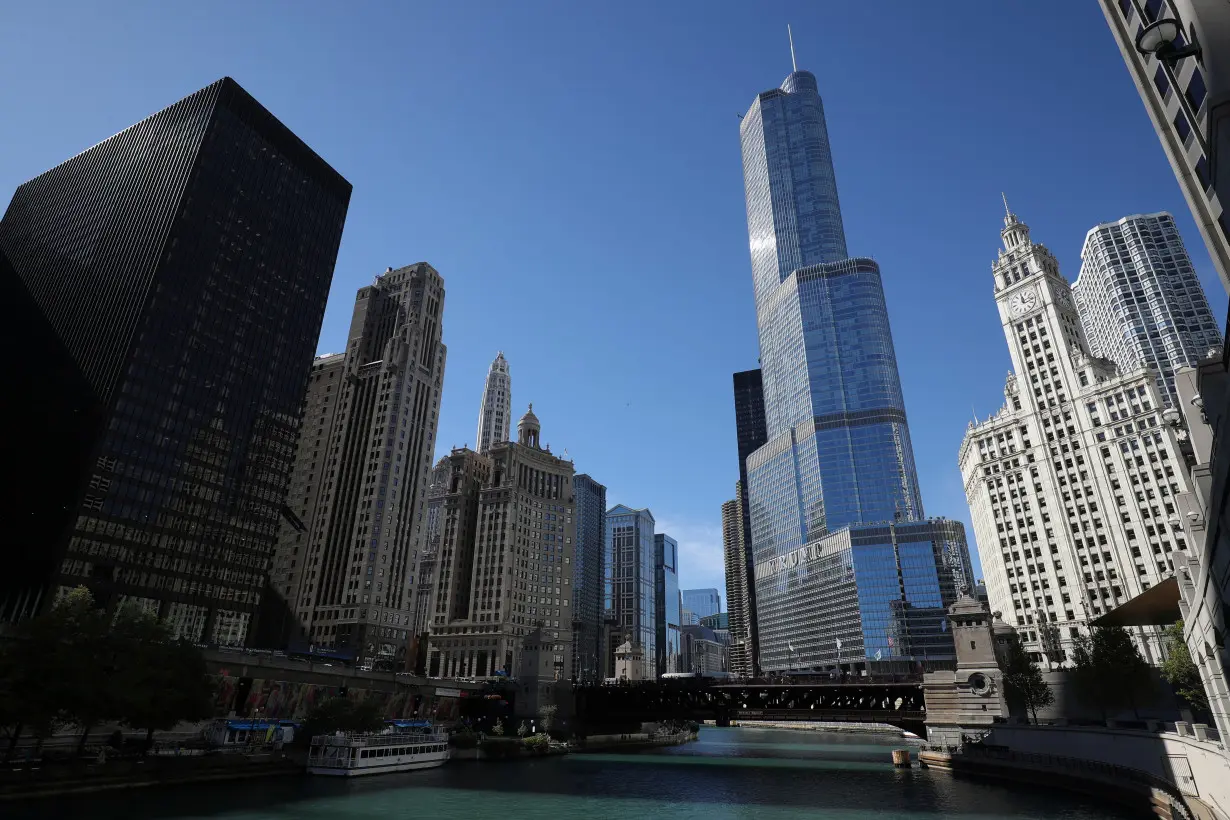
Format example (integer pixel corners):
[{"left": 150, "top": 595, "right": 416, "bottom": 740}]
[{"left": 2, "top": 727, "right": 1128, "bottom": 820}]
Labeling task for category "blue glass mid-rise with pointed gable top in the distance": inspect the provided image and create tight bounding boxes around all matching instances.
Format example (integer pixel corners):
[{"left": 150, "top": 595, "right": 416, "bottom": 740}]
[{"left": 603, "top": 504, "right": 658, "bottom": 680}]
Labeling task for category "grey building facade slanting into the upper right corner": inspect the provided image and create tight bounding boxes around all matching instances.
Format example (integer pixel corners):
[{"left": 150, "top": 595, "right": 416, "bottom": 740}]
[{"left": 1098, "top": 0, "right": 1230, "bottom": 290}]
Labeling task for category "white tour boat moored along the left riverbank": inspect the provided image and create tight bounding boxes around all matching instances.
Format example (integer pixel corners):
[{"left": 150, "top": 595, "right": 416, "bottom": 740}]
[{"left": 308, "top": 720, "right": 449, "bottom": 777}]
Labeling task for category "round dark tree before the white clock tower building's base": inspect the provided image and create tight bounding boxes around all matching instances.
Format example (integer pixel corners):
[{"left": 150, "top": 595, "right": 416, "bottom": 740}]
[{"left": 1073, "top": 627, "right": 1153, "bottom": 718}]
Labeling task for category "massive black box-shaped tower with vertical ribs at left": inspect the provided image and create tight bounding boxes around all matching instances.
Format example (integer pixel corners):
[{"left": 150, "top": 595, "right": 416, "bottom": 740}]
[{"left": 0, "top": 77, "right": 351, "bottom": 644}]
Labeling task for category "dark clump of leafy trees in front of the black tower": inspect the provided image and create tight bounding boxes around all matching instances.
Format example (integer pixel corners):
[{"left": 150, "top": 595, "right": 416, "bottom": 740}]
[{"left": 0, "top": 586, "right": 213, "bottom": 762}]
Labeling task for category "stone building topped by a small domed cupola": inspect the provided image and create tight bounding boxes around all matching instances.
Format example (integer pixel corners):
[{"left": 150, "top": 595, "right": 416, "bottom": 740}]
[{"left": 427, "top": 406, "right": 577, "bottom": 686}]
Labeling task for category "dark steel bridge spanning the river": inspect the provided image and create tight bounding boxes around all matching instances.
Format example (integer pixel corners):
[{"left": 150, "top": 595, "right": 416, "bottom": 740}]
[{"left": 573, "top": 679, "right": 926, "bottom": 735}]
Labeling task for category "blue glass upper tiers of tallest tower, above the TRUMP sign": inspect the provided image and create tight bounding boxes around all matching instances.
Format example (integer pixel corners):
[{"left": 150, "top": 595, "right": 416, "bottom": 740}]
[{"left": 742, "top": 71, "right": 923, "bottom": 550}]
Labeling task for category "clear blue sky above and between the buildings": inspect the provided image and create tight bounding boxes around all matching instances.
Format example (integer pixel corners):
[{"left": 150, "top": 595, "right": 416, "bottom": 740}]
[{"left": 0, "top": 0, "right": 1225, "bottom": 599}]
